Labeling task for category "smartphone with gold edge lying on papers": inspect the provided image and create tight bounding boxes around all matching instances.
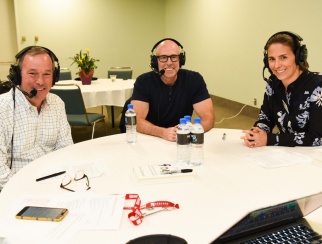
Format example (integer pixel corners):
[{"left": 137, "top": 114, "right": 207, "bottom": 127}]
[{"left": 16, "top": 206, "right": 68, "bottom": 222}]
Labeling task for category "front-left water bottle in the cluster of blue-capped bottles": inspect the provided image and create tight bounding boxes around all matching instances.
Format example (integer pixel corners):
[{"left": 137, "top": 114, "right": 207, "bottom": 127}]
[{"left": 177, "top": 118, "right": 190, "bottom": 164}]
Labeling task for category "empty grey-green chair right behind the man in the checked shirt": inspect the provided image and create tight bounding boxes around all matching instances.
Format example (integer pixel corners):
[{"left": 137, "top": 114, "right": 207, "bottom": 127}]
[{"left": 50, "top": 84, "right": 107, "bottom": 139}]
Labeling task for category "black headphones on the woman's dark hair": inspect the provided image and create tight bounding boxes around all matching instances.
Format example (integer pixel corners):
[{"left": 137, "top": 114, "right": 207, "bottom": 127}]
[{"left": 263, "top": 31, "right": 308, "bottom": 69}]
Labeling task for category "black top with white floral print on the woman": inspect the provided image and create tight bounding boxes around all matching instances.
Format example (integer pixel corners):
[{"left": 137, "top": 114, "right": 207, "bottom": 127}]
[{"left": 254, "top": 71, "right": 322, "bottom": 147}]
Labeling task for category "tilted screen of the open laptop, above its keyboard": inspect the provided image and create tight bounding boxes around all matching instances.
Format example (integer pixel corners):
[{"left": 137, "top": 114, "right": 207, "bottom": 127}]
[{"left": 213, "top": 192, "right": 322, "bottom": 243}]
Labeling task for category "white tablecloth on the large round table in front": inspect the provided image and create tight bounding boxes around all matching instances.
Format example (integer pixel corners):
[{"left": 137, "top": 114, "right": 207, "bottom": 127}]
[{"left": 0, "top": 129, "right": 322, "bottom": 244}]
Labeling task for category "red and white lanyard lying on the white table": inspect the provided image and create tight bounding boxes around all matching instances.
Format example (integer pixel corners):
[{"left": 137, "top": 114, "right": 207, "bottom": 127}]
[{"left": 124, "top": 194, "right": 179, "bottom": 225}]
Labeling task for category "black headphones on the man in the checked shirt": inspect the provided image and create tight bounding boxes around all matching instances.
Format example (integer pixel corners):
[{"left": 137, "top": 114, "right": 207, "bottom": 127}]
[{"left": 8, "top": 46, "right": 60, "bottom": 86}]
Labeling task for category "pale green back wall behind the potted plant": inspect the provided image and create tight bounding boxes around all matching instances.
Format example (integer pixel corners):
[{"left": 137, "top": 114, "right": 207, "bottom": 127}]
[{"left": 15, "top": 0, "right": 165, "bottom": 78}]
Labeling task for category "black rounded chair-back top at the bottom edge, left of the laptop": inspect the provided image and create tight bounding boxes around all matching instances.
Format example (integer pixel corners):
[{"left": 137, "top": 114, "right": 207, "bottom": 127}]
[{"left": 126, "top": 234, "right": 188, "bottom": 244}]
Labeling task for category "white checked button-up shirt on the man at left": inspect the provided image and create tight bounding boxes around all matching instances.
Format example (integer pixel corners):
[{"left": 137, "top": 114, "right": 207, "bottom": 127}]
[{"left": 0, "top": 89, "right": 73, "bottom": 190}]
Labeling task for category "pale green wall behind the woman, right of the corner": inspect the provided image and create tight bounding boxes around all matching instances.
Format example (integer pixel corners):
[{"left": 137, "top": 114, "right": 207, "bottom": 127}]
[{"left": 166, "top": 0, "right": 322, "bottom": 105}]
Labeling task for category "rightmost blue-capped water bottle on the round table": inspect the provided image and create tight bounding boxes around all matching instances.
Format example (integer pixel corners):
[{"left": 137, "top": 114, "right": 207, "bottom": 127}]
[{"left": 189, "top": 118, "right": 204, "bottom": 166}]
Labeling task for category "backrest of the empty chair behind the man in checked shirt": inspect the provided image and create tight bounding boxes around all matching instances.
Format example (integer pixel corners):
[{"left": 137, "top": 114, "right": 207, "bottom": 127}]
[{"left": 50, "top": 84, "right": 87, "bottom": 115}]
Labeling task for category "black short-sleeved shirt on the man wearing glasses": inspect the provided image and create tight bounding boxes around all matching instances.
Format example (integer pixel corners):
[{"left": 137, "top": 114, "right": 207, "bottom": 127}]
[{"left": 132, "top": 69, "right": 210, "bottom": 128}]
